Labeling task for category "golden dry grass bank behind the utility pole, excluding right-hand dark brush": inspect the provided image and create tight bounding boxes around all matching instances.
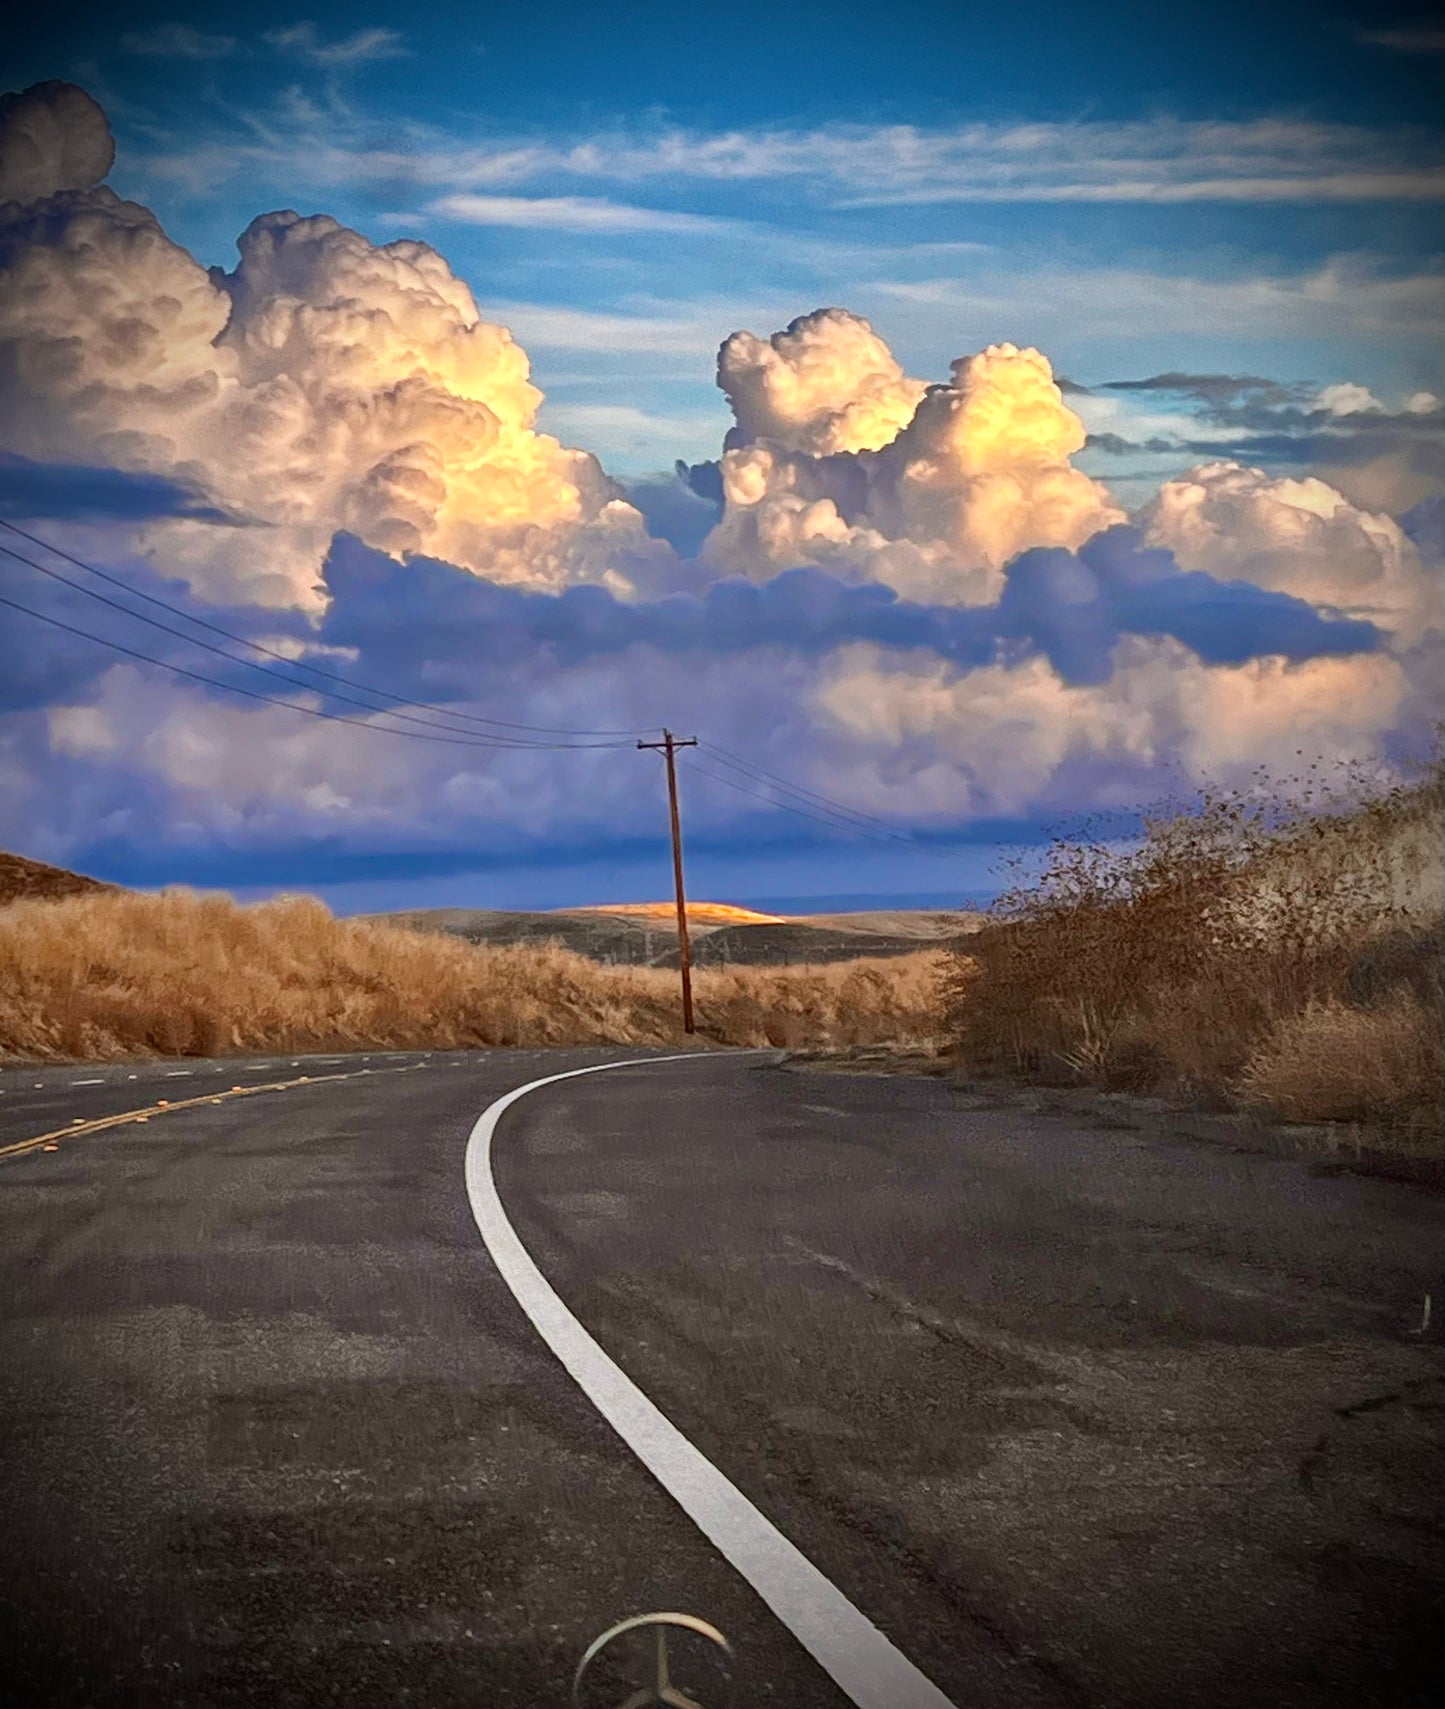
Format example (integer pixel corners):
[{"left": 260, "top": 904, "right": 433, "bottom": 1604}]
[{"left": 0, "top": 890, "right": 938, "bottom": 1061}]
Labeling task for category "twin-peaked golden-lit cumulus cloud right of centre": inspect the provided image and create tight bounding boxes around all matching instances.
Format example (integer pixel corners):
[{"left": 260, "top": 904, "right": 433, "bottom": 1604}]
[{"left": 707, "top": 319, "right": 1124, "bottom": 602}]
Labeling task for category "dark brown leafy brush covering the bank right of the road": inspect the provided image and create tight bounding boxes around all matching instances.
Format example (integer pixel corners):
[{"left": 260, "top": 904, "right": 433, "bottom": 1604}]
[{"left": 945, "top": 764, "right": 1445, "bottom": 1150}]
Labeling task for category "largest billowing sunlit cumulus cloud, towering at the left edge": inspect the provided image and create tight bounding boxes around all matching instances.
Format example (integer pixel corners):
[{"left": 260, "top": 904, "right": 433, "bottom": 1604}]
[{"left": 0, "top": 108, "right": 668, "bottom": 603}]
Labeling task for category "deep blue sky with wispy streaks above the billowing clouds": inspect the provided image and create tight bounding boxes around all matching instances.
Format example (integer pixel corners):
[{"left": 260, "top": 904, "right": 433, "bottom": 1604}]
[{"left": 7, "top": 3, "right": 1442, "bottom": 475}]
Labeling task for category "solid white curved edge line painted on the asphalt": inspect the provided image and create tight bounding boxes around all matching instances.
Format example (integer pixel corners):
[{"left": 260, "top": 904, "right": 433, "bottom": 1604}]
[{"left": 466, "top": 1054, "right": 953, "bottom": 1709}]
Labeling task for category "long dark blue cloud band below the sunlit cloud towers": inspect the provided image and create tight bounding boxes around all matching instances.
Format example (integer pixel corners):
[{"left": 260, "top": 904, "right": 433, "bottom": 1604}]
[{"left": 321, "top": 528, "right": 1378, "bottom": 697}]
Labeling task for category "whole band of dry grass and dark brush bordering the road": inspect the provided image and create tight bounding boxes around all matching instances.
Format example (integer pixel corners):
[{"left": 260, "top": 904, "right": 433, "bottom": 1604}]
[{"left": 0, "top": 764, "right": 1445, "bottom": 1154}]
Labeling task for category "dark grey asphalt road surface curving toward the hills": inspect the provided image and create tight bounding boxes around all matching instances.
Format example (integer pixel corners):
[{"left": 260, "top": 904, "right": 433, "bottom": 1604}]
[{"left": 0, "top": 1051, "right": 1445, "bottom": 1709}]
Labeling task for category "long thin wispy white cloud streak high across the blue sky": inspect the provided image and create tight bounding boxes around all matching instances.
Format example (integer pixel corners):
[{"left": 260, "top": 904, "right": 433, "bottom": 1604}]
[{"left": 129, "top": 110, "right": 1445, "bottom": 207}]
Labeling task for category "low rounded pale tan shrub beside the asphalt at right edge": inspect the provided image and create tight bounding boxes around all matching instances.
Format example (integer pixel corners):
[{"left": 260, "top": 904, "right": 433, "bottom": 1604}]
[{"left": 1238, "top": 995, "right": 1445, "bottom": 1136}]
